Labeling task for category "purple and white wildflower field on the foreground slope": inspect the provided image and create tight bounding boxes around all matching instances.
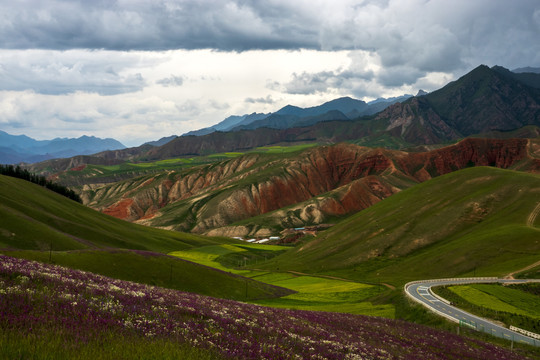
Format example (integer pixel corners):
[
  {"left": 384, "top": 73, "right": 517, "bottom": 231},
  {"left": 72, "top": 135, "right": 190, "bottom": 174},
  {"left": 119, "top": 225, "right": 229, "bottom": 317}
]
[{"left": 0, "top": 255, "right": 522, "bottom": 359}]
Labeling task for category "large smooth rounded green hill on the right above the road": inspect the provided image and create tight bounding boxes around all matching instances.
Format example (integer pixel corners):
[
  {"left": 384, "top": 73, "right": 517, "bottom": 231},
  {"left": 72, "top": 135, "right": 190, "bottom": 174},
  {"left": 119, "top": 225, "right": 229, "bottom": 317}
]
[{"left": 258, "top": 167, "right": 540, "bottom": 285}]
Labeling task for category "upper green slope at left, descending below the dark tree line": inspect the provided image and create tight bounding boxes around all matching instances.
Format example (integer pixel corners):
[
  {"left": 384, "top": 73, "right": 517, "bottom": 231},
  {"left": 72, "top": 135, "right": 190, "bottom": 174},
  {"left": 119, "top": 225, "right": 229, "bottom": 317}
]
[{"left": 0, "top": 176, "right": 221, "bottom": 252}]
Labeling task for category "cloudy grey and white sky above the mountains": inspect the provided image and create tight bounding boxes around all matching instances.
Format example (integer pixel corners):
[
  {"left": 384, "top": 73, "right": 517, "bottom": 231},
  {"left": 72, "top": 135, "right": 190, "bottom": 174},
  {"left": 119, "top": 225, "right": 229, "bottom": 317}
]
[{"left": 0, "top": 0, "right": 540, "bottom": 146}]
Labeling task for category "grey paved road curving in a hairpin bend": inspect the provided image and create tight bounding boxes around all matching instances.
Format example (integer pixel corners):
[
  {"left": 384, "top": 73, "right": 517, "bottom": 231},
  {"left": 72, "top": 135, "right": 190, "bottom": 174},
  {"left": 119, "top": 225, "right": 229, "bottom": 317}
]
[{"left": 405, "top": 278, "right": 540, "bottom": 346}]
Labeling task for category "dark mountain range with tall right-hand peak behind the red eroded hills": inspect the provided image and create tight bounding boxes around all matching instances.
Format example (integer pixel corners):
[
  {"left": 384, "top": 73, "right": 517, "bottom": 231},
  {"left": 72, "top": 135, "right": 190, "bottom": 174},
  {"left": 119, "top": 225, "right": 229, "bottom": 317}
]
[{"left": 50, "top": 65, "right": 540, "bottom": 165}]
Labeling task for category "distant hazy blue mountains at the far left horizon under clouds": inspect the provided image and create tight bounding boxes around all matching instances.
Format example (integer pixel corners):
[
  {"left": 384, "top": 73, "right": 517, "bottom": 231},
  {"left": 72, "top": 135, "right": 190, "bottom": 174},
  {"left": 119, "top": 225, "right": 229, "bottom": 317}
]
[{"left": 0, "top": 131, "right": 126, "bottom": 164}]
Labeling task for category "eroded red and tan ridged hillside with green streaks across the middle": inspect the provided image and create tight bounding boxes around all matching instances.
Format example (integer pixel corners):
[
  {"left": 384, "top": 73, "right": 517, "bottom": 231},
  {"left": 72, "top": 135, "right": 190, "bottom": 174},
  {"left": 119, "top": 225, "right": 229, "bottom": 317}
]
[{"left": 83, "top": 139, "right": 540, "bottom": 236}]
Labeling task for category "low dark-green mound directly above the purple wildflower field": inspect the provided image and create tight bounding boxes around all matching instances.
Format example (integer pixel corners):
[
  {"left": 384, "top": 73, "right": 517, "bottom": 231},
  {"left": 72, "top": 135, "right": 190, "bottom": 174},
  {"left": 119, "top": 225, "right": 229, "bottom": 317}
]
[{"left": 4, "top": 249, "right": 289, "bottom": 301}]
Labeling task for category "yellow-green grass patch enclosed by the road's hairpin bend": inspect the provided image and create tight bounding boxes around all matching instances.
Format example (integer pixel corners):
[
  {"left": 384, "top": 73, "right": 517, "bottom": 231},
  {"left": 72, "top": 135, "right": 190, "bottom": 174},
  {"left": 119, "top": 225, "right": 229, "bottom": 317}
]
[{"left": 448, "top": 284, "right": 540, "bottom": 319}]
